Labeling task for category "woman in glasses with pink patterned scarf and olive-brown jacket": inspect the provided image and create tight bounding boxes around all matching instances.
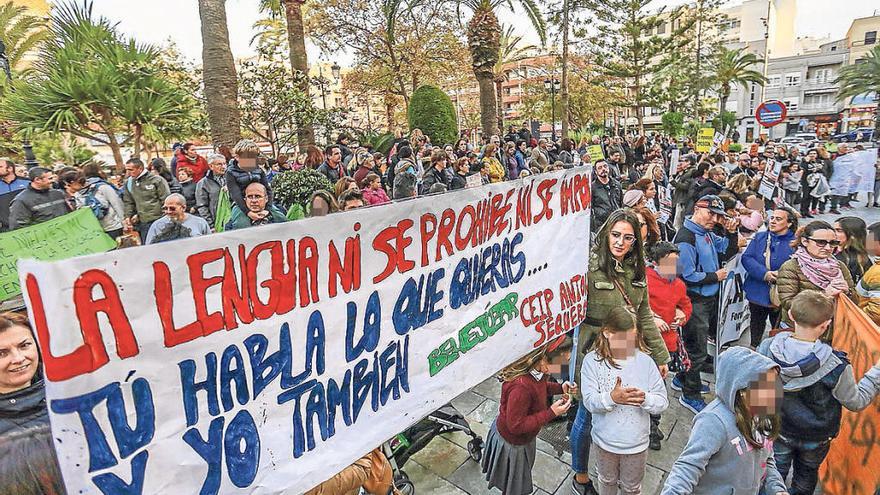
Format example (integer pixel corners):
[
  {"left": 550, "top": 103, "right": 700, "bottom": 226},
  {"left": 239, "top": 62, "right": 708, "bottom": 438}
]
[{"left": 776, "top": 220, "right": 854, "bottom": 334}]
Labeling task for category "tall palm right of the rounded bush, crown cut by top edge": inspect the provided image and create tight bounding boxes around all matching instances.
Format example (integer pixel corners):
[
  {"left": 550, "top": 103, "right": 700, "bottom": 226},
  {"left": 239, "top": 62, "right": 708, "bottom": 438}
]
[{"left": 458, "top": 0, "right": 547, "bottom": 136}]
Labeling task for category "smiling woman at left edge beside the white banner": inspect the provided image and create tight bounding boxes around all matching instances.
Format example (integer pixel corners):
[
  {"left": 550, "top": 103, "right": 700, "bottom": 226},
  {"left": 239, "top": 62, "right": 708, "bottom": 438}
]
[{"left": 0, "top": 312, "right": 49, "bottom": 435}]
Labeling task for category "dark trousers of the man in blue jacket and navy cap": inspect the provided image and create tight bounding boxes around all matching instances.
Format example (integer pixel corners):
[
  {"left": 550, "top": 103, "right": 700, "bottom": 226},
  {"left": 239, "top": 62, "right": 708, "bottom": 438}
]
[{"left": 677, "top": 294, "right": 718, "bottom": 400}]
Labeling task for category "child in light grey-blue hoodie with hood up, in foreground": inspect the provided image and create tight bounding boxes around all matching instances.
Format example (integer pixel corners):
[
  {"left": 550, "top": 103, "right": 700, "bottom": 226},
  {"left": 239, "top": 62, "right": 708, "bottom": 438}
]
[{"left": 660, "top": 347, "right": 788, "bottom": 495}]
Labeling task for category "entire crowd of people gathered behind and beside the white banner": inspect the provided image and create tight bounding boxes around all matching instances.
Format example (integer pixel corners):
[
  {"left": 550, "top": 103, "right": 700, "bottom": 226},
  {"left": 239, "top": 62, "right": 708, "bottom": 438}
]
[{"left": 0, "top": 124, "right": 880, "bottom": 495}]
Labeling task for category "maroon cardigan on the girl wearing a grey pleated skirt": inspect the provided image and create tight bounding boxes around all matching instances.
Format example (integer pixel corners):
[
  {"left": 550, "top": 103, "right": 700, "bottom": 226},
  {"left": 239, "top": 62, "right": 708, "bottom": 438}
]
[{"left": 495, "top": 373, "right": 562, "bottom": 445}]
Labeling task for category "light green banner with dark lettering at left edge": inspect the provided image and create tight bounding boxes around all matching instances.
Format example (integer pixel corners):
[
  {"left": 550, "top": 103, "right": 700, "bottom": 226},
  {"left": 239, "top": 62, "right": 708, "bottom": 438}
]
[{"left": 0, "top": 208, "right": 116, "bottom": 301}]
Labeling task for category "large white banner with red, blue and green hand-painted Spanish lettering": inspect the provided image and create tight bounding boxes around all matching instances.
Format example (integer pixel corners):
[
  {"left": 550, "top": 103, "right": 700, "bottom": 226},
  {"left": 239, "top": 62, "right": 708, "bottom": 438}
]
[{"left": 19, "top": 168, "right": 590, "bottom": 494}]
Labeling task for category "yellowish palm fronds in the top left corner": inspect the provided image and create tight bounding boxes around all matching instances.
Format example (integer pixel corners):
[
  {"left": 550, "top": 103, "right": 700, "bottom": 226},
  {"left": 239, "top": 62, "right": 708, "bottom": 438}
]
[{"left": 0, "top": 2, "right": 49, "bottom": 85}]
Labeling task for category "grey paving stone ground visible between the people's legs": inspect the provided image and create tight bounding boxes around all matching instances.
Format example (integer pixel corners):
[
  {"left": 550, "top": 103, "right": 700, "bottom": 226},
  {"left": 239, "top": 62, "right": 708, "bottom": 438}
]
[{"left": 403, "top": 203, "right": 880, "bottom": 495}]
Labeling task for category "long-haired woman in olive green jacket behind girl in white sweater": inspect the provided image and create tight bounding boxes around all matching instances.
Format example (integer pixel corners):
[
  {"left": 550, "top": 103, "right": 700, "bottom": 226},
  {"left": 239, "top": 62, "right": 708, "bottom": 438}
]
[{"left": 569, "top": 210, "right": 669, "bottom": 494}]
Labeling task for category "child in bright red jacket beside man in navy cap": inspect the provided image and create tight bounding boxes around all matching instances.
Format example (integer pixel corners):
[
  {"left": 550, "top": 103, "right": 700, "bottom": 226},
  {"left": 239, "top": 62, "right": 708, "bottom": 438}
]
[{"left": 645, "top": 241, "right": 692, "bottom": 450}]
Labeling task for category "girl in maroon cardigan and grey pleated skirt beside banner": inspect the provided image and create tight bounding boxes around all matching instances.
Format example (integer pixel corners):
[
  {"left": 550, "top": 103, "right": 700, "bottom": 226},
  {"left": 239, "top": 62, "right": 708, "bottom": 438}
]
[{"left": 482, "top": 337, "right": 577, "bottom": 495}]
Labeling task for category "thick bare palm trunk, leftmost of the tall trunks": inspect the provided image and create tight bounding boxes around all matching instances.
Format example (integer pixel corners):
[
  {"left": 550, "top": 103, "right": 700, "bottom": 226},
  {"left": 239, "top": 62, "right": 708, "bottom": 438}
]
[{"left": 199, "top": 0, "right": 241, "bottom": 147}]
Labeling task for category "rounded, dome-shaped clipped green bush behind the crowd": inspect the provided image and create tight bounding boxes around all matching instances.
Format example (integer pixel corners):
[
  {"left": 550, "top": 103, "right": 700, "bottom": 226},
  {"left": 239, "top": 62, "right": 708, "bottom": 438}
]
[{"left": 407, "top": 85, "right": 458, "bottom": 146}]
